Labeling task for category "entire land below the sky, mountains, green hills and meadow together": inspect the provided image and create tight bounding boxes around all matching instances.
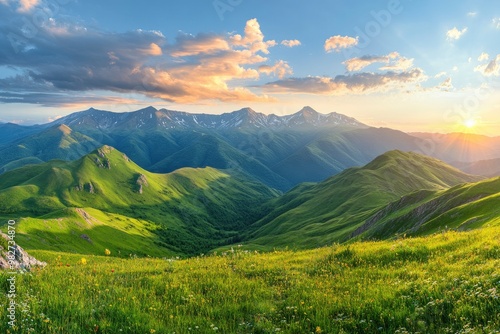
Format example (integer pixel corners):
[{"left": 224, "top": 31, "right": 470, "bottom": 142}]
[{"left": 0, "top": 107, "right": 500, "bottom": 333}]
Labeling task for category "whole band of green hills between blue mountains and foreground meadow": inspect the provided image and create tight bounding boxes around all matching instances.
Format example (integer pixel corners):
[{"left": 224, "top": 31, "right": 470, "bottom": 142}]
[{"left": 0, "top": 146, "right": 500, "bottom": 256}]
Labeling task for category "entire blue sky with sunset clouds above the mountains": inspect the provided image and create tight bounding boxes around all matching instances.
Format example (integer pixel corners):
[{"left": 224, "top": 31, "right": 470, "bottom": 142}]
[{"left": 0, "top": 0, "right": 500, "bottom": 136}]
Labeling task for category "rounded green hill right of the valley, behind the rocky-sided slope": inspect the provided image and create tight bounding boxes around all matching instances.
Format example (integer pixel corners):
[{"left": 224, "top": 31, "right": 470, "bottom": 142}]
[{"left": 248, "top": 151, "right": 480, "bottom": 247}]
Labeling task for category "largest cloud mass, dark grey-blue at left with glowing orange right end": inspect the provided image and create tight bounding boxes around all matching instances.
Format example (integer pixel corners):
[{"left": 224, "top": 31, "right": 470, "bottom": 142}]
[{"left": 0, "top": 16, "right": 282, "bottom": 105}]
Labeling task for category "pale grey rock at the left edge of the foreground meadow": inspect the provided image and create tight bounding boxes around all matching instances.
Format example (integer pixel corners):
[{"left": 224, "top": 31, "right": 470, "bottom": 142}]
[{"left": 0, "top": 232, "right": 47, "bottom": 270}]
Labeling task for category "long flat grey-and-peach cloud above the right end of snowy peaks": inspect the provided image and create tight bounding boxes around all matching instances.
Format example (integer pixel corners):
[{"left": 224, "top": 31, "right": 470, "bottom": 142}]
[{"left": 264, "top": 68, "right": 426, "bottom": 95}]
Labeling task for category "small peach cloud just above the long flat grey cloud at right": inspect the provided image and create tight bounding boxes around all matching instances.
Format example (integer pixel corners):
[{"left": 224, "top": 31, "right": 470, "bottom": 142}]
[{"left": 343, "top": 52, "right": 413, "bottom": 72}]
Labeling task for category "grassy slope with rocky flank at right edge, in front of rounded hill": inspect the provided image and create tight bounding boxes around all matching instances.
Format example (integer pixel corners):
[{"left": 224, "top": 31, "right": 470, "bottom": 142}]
[{"left": 356, "top": 178, "right": 500, "bottom": 238}]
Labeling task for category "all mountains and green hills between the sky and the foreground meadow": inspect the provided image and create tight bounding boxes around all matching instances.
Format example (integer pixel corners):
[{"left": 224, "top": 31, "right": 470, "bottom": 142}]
[{"left": 0, "top": 107, "right": 500, "bottom": 257}]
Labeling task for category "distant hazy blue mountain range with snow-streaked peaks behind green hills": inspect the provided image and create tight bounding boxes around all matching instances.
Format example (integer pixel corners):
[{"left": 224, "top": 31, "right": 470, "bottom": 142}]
[{"left": 0, "top": 107, "right": 500, "bottom": 191}]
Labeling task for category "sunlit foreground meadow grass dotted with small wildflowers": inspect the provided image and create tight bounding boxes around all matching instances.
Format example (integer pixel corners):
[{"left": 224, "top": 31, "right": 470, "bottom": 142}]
[{"left": 0, "top": 227, "right": 500, "bottom": 334}]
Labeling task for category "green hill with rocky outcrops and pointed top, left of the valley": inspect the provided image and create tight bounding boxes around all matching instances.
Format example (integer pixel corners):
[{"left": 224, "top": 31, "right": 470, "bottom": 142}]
[{"left": 0, "top": 146, "right": 276, "bottom": 254}]
